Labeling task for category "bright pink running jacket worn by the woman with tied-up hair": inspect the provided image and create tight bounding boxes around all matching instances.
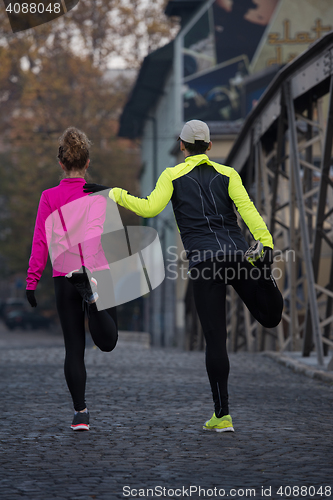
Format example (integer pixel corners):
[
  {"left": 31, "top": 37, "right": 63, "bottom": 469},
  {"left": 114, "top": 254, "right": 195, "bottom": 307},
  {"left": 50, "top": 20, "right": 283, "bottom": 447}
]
[{"left": 26, "top": 177, "right": 109, "bottom": 290}]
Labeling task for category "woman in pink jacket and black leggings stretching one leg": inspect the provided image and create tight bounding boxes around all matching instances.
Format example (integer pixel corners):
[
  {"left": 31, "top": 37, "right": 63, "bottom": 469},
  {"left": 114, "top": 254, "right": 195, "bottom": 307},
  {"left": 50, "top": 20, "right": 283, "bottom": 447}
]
[{"left": 26, "top": 127, "right": 118, "bottom": 430}]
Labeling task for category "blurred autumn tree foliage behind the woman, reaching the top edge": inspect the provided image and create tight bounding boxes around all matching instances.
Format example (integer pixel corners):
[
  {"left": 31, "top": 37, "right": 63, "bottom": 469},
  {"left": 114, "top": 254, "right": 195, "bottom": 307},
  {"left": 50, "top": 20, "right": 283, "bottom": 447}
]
[{"left": 0, "top": 0, "right": 179, "bottom": 300}]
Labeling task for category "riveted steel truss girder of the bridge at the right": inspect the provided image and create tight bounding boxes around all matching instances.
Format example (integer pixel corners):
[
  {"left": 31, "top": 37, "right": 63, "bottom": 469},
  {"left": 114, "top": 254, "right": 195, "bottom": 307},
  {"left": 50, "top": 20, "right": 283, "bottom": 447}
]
[{"left": 227, "top": 33, "right": 333, "bottom": 365}]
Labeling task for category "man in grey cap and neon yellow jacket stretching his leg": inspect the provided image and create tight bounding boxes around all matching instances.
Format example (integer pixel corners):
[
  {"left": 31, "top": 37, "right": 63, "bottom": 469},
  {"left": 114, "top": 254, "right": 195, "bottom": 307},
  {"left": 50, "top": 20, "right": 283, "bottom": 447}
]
[{"left": 84, "top": 120, "right": 283, "bottom": 432}]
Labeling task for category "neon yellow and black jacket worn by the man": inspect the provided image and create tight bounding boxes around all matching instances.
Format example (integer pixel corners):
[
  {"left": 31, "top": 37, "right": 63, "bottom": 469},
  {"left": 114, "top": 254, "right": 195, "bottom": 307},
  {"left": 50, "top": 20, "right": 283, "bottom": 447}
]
[{"left": 109, "top": 154, "right": 273, "bottom": 267}]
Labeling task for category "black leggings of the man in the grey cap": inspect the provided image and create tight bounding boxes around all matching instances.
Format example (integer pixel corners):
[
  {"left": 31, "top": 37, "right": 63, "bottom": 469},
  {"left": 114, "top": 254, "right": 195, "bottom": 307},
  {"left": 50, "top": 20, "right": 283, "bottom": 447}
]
[{"left": 190, "top": 260, "right": 283, "bottom": 417}]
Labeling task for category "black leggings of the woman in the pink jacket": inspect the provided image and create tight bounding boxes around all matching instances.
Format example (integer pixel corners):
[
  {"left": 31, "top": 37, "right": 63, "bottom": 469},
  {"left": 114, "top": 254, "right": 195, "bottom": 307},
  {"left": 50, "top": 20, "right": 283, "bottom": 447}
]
[{"left": 54, "top": 272, "right": 118, "bottom": 411}]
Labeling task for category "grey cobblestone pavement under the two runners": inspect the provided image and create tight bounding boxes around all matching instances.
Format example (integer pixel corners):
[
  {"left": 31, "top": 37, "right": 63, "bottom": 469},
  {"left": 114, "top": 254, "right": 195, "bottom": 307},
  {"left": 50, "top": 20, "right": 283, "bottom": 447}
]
[{"left": 0, "top": 322, "right": 333, "bottom": 500}]
